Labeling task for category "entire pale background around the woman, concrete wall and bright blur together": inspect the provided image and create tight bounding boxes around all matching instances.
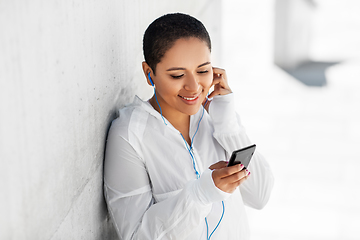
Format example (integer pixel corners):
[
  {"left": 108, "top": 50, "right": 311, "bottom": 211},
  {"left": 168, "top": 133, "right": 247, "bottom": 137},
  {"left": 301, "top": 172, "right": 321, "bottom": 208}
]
[{"left": 0, "top": 0, "right": 360, "bottom": 240}]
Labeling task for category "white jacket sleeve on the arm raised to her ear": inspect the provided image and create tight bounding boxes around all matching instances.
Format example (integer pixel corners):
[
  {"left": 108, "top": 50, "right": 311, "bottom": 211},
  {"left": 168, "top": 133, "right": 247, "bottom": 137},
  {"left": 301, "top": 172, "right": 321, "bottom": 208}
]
[{"left": 209, "top": 93, "right": 274, "bottom": 209}]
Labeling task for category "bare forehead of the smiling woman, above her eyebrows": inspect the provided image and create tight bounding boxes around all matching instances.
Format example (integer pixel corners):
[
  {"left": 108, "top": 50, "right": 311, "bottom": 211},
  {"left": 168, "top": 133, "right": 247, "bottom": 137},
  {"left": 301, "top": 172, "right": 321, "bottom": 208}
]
[{"left": 157, "top": 37, "right": 211, "bottom": 70}]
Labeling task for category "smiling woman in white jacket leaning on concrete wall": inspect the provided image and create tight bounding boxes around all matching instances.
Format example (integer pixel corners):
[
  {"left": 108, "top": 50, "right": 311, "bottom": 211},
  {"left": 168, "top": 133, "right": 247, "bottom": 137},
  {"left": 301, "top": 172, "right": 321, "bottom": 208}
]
[{"left": 104, "top": 13, "right": 273, "bottom": 240}]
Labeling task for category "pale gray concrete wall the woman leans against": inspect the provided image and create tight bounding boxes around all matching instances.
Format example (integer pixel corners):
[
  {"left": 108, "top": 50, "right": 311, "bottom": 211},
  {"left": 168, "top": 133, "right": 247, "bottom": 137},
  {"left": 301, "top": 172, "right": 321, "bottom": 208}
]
[{"left": 0, "top": 0, "right": 221, "bottom": 240}]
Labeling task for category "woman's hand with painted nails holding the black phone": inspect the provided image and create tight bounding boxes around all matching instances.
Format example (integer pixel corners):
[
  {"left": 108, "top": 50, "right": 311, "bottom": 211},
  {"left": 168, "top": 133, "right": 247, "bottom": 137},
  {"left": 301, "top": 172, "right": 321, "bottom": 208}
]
[{"left": 209, "top": 161, "right": 250, "bottom": 193}]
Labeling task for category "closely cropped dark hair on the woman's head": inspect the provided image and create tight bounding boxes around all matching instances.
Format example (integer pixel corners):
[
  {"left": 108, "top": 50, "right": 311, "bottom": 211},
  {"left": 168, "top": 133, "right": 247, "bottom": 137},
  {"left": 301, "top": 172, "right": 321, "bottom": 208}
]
[{"left": 143, "top": 13, "right": 211, "bottom": 74}]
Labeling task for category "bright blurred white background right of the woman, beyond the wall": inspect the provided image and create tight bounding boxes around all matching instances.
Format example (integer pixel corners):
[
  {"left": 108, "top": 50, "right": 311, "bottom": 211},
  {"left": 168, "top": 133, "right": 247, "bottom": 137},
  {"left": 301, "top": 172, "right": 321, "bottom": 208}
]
[{"left": 223, "top": 0, "right": 360, "bottom": 240}]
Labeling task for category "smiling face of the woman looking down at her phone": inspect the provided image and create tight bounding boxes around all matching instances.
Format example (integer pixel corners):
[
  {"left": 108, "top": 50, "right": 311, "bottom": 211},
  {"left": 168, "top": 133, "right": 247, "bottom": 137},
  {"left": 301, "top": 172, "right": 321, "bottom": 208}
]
[{"left": 152, "top": 38, "right": 213, "bottom": 117}]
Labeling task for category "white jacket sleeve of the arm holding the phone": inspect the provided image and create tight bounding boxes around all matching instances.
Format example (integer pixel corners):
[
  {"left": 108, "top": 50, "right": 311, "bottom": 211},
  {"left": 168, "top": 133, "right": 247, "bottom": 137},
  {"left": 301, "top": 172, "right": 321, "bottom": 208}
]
[{"left": 104, "top": 121, "right": 228, "bottom": 240}]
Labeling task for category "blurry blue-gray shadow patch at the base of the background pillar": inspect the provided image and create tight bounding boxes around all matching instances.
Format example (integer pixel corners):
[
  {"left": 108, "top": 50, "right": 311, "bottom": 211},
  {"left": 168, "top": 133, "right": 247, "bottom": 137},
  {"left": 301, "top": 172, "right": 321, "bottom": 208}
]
[{"left": 280, "top": 61, "right": 340, "bottom": 87}]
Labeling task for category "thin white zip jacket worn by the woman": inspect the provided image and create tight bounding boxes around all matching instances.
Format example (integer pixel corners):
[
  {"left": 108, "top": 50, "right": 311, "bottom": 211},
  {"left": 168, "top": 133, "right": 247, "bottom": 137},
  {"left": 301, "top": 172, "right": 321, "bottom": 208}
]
[{"left": 104, "top": 94, "right": 273, "bottom": 240}]
